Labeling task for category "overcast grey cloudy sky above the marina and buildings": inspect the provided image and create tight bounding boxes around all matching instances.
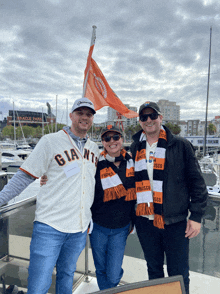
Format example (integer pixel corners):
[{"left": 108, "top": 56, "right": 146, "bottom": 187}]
[{"left": 0, "top": 0, "right": 220, "bottom": 123}]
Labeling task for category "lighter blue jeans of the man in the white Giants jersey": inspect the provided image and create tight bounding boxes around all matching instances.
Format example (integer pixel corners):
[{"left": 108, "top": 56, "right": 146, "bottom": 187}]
[{"left": 27, "top": 222, "right": 87, "bottom": 294}]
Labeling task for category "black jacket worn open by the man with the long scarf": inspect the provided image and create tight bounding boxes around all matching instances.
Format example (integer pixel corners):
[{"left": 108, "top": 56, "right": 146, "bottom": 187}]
[{"left": 131, "top": 126, "right": 208, "bottom": 225}]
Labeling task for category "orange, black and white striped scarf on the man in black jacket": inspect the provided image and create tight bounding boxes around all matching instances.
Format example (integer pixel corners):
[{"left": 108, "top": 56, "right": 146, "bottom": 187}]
[{"left": 135, "top": 127, "right": 167, "bottom": 229}]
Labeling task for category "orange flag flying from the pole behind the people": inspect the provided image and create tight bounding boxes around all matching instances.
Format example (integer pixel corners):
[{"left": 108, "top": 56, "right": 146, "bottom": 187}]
[{"left": 84, "top": 58, "right": 138, "bottom": 118}]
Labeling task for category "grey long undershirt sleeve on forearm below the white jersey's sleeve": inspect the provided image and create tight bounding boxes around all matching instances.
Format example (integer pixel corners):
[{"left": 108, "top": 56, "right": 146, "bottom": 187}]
[{"left": 0, "top": 170, "right": 35, "bottom": 206}]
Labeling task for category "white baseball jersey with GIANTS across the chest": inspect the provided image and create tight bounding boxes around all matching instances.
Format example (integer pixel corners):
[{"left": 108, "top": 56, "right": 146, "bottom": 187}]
[{"left": 20, "top": 130, "right": 99, "bottom": 233}]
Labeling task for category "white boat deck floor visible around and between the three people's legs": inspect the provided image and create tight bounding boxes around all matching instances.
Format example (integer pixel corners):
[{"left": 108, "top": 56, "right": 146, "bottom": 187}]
[{"left": 0, "top": 250, "right": 220, "bottom": 294}]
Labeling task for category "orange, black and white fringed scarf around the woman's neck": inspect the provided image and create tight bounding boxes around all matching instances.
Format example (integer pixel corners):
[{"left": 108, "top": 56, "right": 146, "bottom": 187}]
[{"left": 99, "top": 149, "right": 136, "bottom": 202}]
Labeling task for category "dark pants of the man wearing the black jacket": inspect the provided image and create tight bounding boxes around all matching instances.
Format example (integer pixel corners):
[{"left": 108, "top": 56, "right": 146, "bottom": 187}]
[{"left": 135, "top": 216, "right": 189, "bottom": 294}]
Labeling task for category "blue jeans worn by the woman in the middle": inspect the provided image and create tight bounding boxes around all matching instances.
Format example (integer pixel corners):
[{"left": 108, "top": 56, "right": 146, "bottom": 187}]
[{"left": 90, "top": 220, "right": 129, "bottom": 290}]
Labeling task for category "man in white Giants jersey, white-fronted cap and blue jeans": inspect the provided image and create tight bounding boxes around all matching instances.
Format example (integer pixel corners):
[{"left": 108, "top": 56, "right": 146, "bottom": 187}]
[{"left": 0, "top": 98, "right": 99, "bottom": 294}]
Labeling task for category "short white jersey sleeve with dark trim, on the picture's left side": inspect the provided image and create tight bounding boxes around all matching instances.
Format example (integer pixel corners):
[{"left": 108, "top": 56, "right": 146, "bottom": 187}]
[{"left": 20, "top": 135, "right": 53, "bottom": 179}]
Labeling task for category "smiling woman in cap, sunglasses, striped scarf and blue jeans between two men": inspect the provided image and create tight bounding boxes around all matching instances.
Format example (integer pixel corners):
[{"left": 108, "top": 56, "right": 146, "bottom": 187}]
[{"left": 90, "top": 125, "right": 136, "bottom": 290}]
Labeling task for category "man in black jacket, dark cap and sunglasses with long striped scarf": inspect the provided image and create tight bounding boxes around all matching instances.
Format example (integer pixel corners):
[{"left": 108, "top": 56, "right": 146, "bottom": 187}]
[{"left": 131, "top": 102, "right": 208, "bottom": 293}]
